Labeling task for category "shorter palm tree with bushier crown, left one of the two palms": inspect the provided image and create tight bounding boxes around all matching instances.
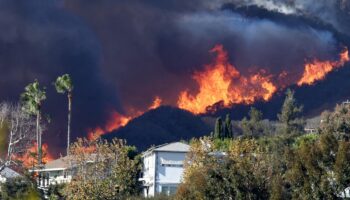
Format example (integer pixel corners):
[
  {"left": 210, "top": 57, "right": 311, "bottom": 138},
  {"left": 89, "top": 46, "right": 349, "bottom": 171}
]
[{"left": 21, "top": 80, "right": 46, "bottom": 166}]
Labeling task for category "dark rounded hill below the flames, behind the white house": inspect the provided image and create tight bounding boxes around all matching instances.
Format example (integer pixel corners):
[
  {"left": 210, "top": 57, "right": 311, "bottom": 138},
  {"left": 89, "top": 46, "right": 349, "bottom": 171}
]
[{"left": 103, "top": 106, "right": 211, "bottom": 151}]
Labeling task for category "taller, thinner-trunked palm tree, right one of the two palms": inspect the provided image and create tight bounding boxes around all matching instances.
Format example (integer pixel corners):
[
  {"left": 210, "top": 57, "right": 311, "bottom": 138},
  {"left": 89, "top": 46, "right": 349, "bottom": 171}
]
[{"left": 55, "top": 74, "right": 73, "bottom": 155}]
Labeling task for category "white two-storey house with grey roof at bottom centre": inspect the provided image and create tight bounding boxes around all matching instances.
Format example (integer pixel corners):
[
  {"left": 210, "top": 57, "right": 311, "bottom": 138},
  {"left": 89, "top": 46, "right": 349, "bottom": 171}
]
[{"left": 139, "top": 142, "right": 190, "bottom": 197}]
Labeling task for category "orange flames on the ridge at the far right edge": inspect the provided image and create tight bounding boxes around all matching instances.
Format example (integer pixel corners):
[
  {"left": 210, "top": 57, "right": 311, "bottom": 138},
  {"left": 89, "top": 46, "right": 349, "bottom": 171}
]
[{"left": 297, "top": 48, "right": 349, "bottom": 86}]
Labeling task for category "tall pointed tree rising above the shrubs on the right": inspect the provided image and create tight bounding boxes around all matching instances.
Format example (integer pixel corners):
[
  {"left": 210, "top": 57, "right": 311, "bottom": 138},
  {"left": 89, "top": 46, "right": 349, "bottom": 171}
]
[{"left": 277, "top": 89, "right": 305, "bottom": 134}]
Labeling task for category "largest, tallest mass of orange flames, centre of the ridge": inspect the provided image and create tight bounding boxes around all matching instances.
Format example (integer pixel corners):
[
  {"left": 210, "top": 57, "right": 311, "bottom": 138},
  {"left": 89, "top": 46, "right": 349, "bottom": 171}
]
[{"left": 177, "top": 45, "right": 277, "bottom": 114}]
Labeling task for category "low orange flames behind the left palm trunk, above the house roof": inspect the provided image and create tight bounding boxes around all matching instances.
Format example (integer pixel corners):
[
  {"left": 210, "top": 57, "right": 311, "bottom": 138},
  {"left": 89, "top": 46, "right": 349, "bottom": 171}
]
[{"left": 14, "top": 143, "right": 54, "bottom": 168}]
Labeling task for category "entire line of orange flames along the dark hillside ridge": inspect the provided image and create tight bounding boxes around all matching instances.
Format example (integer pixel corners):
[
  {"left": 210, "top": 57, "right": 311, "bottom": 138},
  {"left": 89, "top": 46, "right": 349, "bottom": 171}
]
[{"left": 89, "top": 45, "right": 349, "bottom": 139}]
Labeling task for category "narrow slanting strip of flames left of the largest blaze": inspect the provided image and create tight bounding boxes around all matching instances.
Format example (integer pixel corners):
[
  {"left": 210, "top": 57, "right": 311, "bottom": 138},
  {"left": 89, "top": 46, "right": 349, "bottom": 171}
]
[{"left": 88, "top": 96, "right": 162, "bottom": 140}]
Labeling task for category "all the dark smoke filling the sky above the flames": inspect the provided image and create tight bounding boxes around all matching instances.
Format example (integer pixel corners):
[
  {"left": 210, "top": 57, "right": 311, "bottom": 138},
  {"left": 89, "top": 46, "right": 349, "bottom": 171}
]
[{"left": 0, "top": 0, "right": 349, "bottom": 155}]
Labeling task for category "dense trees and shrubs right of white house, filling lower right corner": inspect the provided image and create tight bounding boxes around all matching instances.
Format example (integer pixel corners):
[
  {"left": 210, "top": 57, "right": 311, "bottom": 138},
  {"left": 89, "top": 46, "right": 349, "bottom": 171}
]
[{"left": 175, "top": 91, "right": 350, "bottom": 200}]
